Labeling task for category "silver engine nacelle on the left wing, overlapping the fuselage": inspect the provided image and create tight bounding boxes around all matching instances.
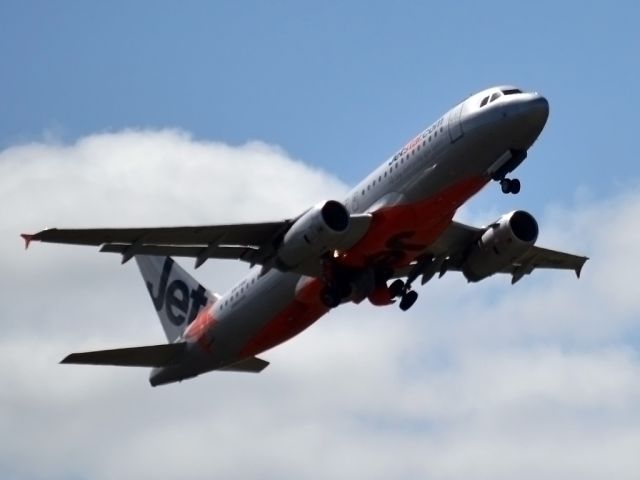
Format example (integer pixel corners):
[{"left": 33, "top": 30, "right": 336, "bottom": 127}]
[{"left": 277, "top": 200, "right": 350, "bottom": 270}]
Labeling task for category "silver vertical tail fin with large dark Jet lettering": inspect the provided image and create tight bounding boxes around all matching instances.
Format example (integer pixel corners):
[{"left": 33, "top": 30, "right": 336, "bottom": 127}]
[{"left": 134, "top": 255, "right": 216, "bottom": 342}]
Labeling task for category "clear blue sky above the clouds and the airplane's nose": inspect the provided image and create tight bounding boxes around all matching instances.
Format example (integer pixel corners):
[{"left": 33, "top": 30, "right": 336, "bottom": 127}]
[{"left": 0, "top": 1, "right": 640, "bottom": 201}]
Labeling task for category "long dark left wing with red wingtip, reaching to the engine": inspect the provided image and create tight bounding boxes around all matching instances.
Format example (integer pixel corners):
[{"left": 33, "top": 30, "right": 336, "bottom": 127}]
[{"left": 22, "top": 220, "right": 293, "bottom": 268}]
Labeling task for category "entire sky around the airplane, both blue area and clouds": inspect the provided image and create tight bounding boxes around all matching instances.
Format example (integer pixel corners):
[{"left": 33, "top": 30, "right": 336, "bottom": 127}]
[{"left": 0, "top": 1, "right": 640, "bottom": 480}]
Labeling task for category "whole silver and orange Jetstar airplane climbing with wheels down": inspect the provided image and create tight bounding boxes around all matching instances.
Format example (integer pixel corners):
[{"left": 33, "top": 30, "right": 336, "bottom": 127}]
[{"left": 22, "top": 85, "right": 587, "bottom": 386}]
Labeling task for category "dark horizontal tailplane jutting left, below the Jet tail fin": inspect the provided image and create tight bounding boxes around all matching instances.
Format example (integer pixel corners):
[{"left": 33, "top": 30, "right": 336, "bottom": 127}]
[{"left": 60, "top": 342, "right": 186, "bottom": 367}]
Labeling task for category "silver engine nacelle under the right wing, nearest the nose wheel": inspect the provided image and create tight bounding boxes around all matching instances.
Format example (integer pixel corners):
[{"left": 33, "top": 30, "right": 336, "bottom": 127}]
[{"left": 462, "top": 210, "right": 538, "bottom": 282}]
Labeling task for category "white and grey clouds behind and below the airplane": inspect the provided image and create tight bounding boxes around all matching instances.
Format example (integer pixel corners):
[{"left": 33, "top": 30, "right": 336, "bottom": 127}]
[{"left": 0, "top": 130, "right": 640, "bottom": 479}]
